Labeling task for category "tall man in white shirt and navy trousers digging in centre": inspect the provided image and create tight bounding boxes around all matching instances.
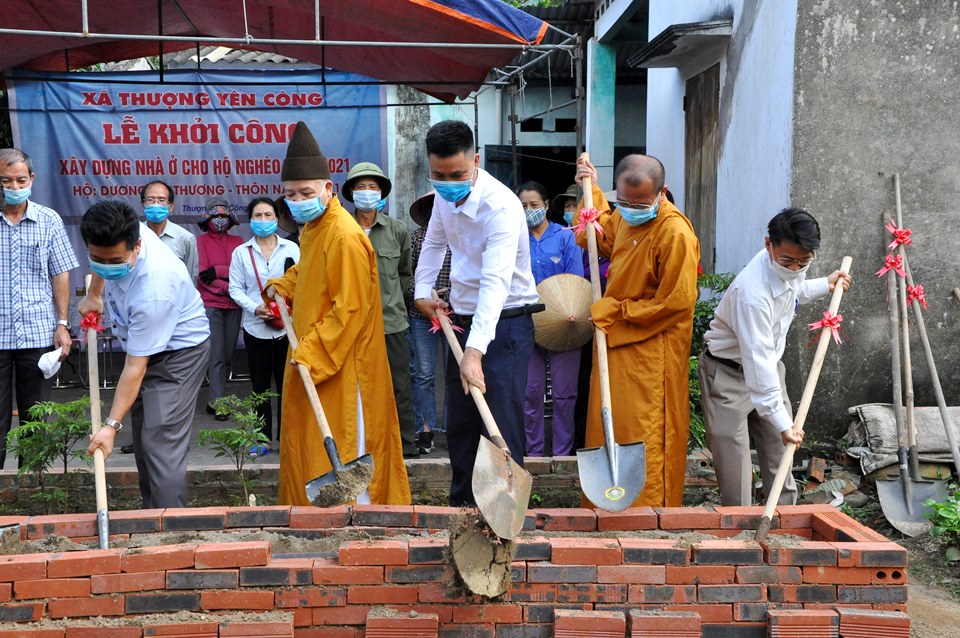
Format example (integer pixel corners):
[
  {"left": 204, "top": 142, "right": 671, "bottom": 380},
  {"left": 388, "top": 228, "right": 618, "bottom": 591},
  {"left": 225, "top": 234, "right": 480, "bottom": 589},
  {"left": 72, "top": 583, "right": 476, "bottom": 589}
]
[{"left": 414, "top": 120, "right": 543, "bottom": 507}]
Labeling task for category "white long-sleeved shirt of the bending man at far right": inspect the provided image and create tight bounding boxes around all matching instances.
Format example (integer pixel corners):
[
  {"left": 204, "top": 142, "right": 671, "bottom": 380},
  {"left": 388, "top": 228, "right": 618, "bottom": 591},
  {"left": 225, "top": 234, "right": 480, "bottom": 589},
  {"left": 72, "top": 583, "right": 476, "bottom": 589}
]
[{"left": 704, "top": 249, "right": 830, "bottom": 432}]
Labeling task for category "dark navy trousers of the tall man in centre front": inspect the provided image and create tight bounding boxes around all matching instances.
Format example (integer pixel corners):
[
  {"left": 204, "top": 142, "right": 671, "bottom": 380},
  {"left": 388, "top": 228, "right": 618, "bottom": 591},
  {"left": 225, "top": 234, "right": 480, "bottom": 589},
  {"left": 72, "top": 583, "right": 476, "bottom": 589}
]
[{"left": 447, "top": 315, "right": 533, "bottom": 507}]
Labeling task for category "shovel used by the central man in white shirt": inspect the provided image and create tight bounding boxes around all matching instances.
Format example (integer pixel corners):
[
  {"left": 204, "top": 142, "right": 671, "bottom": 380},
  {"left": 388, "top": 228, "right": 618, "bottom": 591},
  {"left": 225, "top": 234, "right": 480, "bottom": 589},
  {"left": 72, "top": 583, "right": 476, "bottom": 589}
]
[{"left": 436, "top": 308, "right": 533, "bottom": 539}]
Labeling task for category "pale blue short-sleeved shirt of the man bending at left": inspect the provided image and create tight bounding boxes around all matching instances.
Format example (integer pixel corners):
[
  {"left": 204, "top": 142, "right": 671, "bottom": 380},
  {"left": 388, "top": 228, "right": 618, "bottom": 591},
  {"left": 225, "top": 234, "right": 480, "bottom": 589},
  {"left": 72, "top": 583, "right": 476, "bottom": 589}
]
[{"left": 106, "top": 224, "right": 210, "bottom": 357}]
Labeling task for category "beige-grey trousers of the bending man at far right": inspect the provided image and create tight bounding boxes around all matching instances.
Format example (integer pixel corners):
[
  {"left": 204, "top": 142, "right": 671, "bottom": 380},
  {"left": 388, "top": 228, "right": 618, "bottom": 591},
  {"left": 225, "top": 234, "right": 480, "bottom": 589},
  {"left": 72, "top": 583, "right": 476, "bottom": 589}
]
[{"left": 700, "top": 354, "right": 797, "bottom": 505}]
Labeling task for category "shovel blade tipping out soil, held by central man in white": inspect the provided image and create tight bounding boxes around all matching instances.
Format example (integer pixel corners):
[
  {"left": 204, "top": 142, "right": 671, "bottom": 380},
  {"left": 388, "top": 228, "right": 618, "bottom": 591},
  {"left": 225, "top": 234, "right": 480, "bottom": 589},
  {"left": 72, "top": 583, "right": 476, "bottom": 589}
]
[{"left": 473, "top": 436, "right": 533, "bottom": 539}]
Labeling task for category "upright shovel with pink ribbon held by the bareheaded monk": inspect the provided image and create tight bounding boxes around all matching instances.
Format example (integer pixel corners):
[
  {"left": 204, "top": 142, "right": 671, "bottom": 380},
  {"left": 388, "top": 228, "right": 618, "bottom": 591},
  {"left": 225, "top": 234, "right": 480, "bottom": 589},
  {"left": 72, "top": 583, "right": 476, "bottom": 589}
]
[{"left": 577, "top": 153, "right": 647, "bottom": 512}]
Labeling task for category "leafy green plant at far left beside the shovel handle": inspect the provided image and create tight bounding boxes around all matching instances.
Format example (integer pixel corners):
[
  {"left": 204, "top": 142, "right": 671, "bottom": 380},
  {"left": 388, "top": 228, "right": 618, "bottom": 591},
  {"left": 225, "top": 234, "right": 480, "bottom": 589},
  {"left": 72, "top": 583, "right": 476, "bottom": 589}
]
[{"left": 7, "top": 396, "right": 90, "bottom": 514}]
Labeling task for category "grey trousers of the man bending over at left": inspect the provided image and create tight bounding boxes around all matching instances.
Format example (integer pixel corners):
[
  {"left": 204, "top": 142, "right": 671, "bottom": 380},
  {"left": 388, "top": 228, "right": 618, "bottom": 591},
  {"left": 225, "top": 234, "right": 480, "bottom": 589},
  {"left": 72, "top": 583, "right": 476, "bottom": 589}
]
[{"left": 130, "top": 340, "right": 210, "bottom": 509}]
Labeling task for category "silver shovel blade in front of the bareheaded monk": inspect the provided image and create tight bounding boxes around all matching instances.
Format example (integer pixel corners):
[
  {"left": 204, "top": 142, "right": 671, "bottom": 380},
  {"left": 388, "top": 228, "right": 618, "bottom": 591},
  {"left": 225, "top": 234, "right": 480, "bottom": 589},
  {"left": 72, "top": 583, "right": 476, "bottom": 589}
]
[{"left": 577, "top": 441, "right": 647, "bottom": 512}]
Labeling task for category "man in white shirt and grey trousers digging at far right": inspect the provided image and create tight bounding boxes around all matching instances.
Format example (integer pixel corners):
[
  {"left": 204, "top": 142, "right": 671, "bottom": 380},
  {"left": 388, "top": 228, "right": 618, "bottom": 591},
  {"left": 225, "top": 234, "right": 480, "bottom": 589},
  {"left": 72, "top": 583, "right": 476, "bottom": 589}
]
[{"left": 700, "top": 208, "right": 852, "bottom": 505}]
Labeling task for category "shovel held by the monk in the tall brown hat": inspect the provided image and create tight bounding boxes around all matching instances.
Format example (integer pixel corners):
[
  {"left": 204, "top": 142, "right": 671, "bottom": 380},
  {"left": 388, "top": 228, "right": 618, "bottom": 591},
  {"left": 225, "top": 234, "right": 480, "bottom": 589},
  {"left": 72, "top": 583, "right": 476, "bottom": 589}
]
[{"left": 273, "top": 293, "right": 373, "bottom": 507}]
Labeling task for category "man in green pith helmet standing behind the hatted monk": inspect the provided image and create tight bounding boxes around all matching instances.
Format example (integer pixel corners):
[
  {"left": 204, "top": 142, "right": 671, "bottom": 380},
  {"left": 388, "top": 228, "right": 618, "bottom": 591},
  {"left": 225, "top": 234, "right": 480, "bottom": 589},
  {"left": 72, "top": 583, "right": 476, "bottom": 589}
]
[{"left": 340, "top": 162, "right": 420, "bottom": 458}]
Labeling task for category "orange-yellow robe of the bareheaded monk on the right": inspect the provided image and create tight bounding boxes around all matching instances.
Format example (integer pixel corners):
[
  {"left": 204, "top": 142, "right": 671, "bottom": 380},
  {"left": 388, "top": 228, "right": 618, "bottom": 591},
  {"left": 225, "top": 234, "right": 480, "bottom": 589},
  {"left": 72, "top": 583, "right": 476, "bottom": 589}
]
[{"left": 577, "top": 186, "right": 700, "bottom": 507}]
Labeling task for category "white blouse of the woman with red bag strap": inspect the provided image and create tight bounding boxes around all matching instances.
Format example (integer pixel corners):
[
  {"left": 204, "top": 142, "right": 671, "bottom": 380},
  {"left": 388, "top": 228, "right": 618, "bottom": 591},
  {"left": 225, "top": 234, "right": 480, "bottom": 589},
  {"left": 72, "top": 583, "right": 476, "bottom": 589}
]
[{"left": 230, "top": 237, "right": 300, "bottom": 339}]
